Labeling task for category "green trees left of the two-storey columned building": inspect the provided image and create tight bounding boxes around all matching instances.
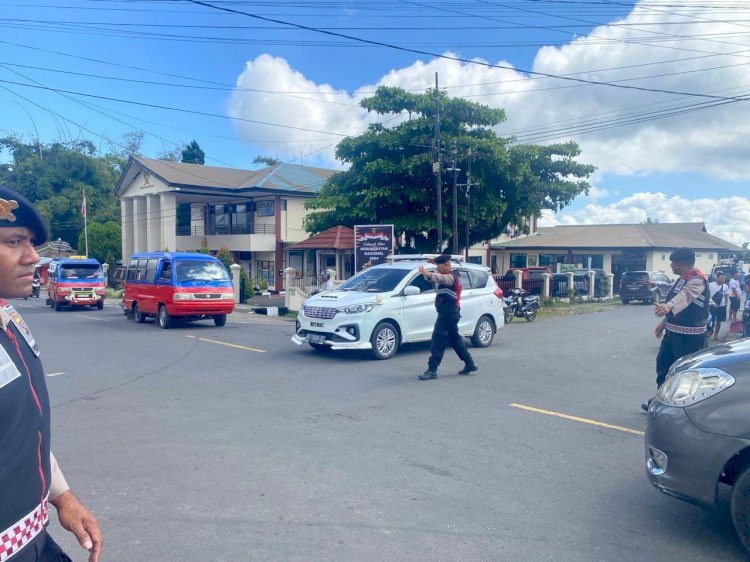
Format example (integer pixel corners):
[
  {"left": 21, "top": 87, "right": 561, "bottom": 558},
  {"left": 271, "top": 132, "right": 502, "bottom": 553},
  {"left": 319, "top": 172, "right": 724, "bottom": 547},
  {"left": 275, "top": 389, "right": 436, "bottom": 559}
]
[{"left": 0, "top": 137, "right": 120, "bottom": 246}]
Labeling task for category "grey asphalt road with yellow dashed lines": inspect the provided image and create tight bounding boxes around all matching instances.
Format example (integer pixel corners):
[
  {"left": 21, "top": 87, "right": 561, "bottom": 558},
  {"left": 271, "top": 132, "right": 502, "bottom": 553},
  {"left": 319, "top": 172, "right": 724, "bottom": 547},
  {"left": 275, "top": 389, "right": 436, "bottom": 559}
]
[{"left": 14, "top": 299, "right": 746, "bottom": 561}]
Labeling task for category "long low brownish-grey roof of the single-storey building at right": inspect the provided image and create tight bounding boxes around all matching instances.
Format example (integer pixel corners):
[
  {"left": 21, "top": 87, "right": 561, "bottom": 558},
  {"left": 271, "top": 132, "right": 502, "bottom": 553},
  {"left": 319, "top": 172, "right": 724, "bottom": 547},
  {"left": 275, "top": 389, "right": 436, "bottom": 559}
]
[{"left": 492, "top": 222, "right": 742, "bottom": 251}]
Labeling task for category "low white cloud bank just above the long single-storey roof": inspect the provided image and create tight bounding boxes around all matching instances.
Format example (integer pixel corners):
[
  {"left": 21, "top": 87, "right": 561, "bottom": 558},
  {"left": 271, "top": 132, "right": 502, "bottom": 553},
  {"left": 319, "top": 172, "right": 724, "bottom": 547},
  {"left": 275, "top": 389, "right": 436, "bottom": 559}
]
[{"left": 539, "top": 193, "right": 750, "bottom": 246}]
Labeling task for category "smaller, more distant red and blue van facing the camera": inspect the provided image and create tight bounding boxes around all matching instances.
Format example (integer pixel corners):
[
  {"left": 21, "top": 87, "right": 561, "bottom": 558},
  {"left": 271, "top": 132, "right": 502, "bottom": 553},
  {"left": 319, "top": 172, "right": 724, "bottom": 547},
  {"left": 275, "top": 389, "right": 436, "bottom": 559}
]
[{"left": 47, "top": 256, "right": 106, "bottom": 311}]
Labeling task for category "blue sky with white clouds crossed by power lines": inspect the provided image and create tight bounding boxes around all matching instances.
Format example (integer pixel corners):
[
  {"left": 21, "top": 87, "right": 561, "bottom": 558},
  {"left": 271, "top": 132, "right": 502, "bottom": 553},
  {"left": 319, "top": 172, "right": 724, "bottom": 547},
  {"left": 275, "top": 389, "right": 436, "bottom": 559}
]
[{"left": 0, "top": 0, "right": 750, "bottom": 245}]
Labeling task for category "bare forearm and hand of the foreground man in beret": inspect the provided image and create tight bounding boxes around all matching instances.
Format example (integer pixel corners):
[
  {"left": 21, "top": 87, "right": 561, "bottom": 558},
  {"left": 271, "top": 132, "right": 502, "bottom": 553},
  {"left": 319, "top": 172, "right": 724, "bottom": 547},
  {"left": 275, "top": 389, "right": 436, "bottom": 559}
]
[{"left": 50, "top": 453, "right": 103, "bottom": 562}]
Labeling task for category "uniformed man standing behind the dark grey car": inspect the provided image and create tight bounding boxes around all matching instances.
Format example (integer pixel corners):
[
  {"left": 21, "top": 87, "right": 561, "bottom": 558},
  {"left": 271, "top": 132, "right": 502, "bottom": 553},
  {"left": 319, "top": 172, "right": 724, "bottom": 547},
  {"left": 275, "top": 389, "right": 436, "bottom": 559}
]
[{"left": 641, "top": 248, "right": 710, "bottom": 410}]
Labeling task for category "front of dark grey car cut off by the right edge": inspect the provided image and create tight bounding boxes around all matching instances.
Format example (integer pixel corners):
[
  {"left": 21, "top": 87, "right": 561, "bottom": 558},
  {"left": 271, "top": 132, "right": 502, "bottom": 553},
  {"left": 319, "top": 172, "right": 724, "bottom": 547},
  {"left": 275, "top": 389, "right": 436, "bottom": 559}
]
[{"left": 645, "top": 339, "right": 750, "bottom": 550}]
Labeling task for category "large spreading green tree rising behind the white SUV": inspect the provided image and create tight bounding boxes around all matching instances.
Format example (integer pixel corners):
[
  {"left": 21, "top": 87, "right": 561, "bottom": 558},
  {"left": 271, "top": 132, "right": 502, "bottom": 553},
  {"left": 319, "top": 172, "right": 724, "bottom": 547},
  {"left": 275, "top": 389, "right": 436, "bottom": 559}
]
[{"left": 305, "top": 87, "right": 595, "bottom": 251}]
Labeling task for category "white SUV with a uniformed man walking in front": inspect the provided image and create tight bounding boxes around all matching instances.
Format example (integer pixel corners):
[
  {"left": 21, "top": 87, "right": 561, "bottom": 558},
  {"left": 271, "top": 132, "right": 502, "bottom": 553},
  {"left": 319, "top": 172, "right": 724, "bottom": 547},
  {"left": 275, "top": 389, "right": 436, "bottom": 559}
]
[{"left": 292, "top": 256, "right": 504, "bottom": 359}]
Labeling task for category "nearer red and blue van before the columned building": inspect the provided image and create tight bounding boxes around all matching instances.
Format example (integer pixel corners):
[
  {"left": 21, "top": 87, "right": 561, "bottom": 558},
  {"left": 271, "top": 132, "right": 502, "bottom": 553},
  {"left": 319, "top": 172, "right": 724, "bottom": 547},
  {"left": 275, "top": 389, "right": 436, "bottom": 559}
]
[{"left": 121, "top": 252, "right": 234, "bottom": 329}]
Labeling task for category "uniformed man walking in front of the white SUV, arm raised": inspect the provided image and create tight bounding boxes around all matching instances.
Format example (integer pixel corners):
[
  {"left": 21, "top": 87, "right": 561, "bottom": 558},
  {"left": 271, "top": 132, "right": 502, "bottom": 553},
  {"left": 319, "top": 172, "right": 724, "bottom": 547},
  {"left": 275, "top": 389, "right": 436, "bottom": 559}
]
[{"left": 419, "top": 254, "right": 479, "bottom": 381}]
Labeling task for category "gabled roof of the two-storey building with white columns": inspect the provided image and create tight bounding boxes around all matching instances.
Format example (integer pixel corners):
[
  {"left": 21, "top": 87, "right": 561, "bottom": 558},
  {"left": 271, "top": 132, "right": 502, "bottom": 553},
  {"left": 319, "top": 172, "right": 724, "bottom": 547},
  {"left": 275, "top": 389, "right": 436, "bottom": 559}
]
[{"left": 115, "top": 157, "right": 335, "bottom": 196}]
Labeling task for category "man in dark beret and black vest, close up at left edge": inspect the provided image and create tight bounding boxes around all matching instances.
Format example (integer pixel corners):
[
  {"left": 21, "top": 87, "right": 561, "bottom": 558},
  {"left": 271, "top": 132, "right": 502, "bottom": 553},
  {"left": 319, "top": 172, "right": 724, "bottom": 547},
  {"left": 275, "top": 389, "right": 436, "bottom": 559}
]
[{"left": 0, "top": 186, "right": 102, "bottom": 562}]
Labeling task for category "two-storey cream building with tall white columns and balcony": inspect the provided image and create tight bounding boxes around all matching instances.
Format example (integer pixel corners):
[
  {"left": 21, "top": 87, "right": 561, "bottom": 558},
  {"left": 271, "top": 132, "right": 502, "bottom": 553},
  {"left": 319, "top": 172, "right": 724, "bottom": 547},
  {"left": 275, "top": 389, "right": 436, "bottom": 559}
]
[{"left": 114, "top": 158, "right": 334, "bottom": 290}]
